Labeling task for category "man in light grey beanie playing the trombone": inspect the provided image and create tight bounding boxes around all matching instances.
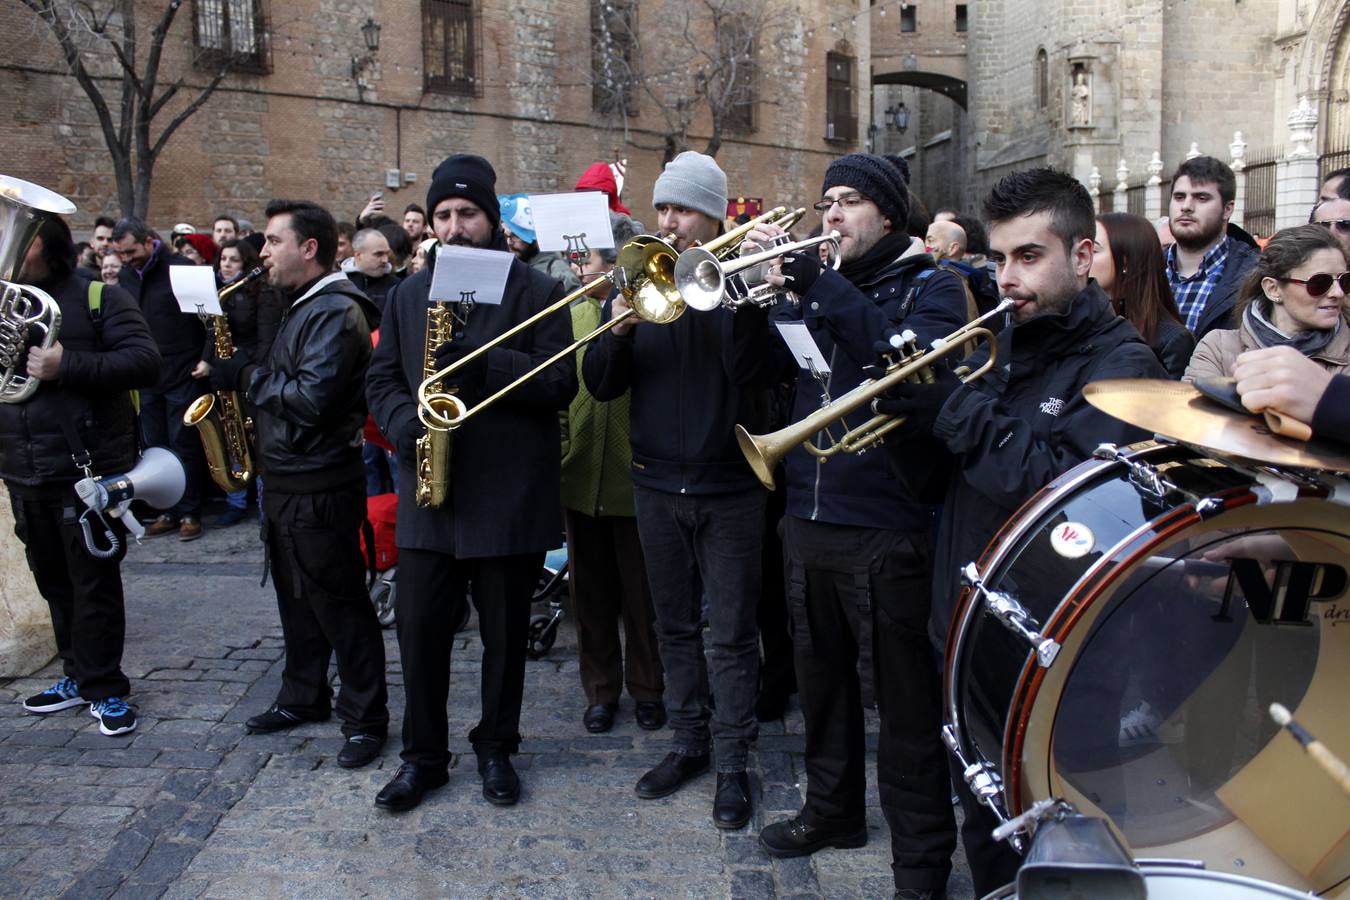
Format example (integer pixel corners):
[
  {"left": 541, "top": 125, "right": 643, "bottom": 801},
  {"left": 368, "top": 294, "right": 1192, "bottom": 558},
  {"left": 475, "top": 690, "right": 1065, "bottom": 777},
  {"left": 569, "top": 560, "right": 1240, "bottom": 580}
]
[{"left": 582, "top": 151, "right": 765, "bottom": 828}]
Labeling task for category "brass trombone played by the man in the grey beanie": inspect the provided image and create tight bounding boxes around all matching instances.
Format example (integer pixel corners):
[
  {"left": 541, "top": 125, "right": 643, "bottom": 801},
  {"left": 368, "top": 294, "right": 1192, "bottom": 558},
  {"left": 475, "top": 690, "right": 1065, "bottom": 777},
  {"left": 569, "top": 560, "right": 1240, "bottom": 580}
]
[{"left": 417, "top": 206, "right": 787, "bottom": 430}]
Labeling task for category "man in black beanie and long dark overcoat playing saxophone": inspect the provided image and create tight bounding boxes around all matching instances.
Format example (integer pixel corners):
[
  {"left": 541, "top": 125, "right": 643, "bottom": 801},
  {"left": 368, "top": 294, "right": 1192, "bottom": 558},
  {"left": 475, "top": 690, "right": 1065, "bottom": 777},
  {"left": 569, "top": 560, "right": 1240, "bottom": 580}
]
[{"left": 367, "top": 154, "right": 576, "bottom": 812}]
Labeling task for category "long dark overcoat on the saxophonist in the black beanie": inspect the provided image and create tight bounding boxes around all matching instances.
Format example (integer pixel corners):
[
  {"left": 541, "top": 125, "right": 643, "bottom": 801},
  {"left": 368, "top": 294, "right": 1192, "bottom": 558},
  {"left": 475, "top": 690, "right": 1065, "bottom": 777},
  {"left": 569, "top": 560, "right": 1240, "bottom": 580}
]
[{"left": 366, "top": 246, "right": 576, "bottom": 559}]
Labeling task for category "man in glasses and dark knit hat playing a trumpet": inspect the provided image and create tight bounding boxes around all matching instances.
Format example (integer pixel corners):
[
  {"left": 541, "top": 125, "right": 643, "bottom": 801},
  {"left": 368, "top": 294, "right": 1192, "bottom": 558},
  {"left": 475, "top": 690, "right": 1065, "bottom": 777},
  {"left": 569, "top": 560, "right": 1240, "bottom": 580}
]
[{"left": 737, "top": 154, "right": 967, "bottom": 897}]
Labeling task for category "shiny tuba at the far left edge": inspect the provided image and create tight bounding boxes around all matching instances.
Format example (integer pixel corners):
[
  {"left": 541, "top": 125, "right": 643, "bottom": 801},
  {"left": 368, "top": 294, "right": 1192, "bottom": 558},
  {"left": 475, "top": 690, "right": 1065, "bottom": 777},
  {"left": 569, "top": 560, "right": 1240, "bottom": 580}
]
[{"left": 0, "top": 175, "right": 76, "bottom": 403}]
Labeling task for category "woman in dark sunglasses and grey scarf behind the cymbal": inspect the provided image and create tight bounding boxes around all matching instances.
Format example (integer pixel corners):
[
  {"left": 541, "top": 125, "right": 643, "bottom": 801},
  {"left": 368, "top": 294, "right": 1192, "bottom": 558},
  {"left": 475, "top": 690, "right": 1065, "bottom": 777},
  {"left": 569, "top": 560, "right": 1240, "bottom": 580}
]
[{"left": 1185, "top": 225, "right": 1350, "bottom": 381}]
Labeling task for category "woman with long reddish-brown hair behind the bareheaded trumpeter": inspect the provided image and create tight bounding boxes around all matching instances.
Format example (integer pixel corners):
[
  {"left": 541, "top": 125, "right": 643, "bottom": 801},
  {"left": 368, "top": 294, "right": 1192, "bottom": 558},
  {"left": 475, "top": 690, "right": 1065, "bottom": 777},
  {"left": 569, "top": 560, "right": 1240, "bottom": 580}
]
[{"left": 1088, "top": 212, "right": 1195, "bottom": 378}]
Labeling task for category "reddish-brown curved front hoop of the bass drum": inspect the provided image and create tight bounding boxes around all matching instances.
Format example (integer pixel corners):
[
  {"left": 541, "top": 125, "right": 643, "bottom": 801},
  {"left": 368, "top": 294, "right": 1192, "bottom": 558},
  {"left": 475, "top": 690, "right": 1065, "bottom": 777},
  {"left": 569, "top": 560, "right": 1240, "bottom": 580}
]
[{"left": 1000, "top": 488, "right": 1257, "bottom": 815}]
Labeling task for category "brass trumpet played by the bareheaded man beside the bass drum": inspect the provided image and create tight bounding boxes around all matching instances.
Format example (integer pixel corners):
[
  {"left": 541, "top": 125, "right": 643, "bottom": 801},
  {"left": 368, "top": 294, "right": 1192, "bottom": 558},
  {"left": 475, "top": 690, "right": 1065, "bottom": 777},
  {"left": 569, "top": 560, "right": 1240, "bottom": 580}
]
[{"left": 736, "top": 298, "right": 1013, "bottom": 490}]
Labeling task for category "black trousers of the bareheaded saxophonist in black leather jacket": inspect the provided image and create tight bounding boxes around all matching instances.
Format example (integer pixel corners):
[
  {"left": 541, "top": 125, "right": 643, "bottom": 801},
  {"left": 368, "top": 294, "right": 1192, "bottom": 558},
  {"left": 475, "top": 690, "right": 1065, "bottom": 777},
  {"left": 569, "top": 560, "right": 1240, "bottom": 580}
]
[{"left": 262, "top": 482, "right": 389, "bottom": 735}]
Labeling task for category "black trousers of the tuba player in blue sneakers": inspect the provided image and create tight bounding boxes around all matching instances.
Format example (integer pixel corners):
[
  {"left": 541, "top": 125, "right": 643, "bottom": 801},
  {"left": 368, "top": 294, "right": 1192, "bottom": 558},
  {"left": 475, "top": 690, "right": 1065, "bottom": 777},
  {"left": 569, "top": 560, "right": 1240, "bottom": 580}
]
[{"left": 9, "top": 486, "right": 131, "bottom": 700}]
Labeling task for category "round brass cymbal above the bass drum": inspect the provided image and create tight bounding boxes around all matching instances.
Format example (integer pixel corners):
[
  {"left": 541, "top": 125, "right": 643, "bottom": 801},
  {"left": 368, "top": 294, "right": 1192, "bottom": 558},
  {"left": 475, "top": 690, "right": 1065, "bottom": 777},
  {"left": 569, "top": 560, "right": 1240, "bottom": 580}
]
[{"left": 1083, "top": 378, "right": 1350, "bottom": 472}]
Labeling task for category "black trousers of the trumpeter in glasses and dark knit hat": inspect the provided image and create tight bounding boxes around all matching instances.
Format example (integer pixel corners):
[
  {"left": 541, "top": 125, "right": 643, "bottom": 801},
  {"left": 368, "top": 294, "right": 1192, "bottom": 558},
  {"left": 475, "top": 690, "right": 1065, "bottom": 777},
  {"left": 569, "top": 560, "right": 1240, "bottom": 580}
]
[{"left": 783, "top": 515, "right": 956, "bottom": 891}]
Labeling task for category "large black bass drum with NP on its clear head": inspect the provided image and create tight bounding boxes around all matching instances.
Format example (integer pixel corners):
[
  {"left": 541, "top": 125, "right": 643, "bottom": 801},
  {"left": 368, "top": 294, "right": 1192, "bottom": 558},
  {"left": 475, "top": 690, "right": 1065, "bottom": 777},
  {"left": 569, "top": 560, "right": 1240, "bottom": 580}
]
[{"left": 944, "top": 443, "right": 1350, "bottom": 896}]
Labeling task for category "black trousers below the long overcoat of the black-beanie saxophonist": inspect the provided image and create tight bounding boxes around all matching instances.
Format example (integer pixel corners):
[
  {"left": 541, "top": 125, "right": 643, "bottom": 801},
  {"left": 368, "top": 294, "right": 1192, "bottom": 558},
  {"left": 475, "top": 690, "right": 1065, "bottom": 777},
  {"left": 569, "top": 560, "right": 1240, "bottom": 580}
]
[{"left": 394, "top": 548, "right": 544, "bottom": 769}]
